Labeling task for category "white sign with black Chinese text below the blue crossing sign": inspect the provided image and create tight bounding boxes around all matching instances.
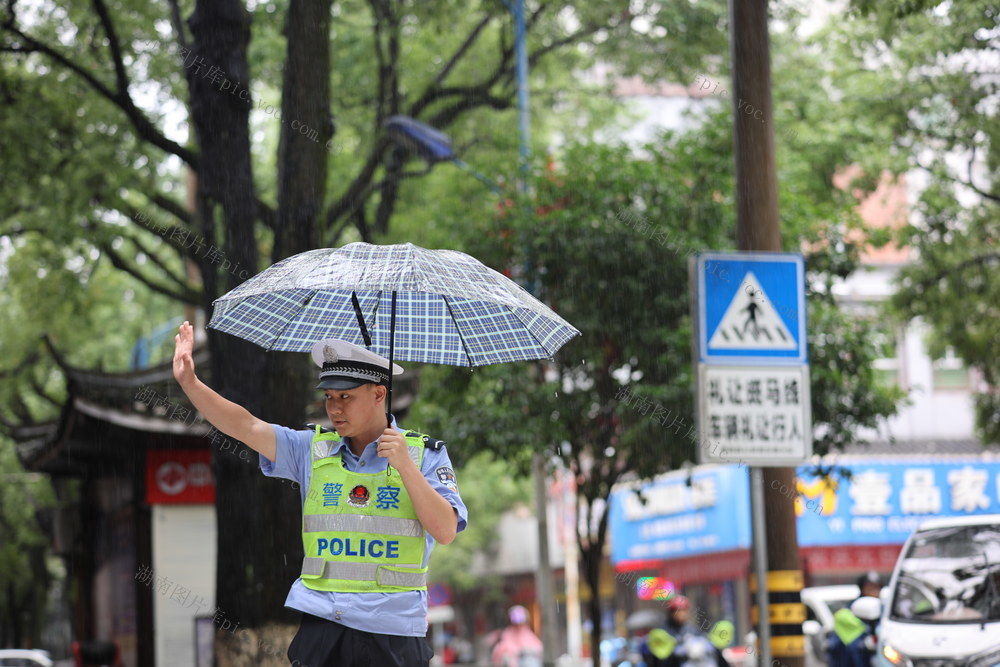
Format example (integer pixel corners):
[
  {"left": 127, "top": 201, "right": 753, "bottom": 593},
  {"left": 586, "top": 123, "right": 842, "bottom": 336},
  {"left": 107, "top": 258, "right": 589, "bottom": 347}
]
[{"left": 698, "top": 364, "right": 812, "bottom": 466}]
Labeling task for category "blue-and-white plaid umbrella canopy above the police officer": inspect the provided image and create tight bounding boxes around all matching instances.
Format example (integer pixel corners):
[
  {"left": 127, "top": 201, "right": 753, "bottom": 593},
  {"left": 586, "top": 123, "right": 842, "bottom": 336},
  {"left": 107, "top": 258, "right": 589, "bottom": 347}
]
[{"left": 208, "top": 243, "right": 580, "bottom": 366}]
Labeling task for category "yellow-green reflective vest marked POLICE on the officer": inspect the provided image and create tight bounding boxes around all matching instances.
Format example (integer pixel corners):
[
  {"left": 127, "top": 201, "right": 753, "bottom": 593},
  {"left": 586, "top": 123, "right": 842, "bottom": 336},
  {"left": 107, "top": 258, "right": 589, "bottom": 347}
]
[{"left": 301, "top": 428, "right": 427, "bottom": 593}]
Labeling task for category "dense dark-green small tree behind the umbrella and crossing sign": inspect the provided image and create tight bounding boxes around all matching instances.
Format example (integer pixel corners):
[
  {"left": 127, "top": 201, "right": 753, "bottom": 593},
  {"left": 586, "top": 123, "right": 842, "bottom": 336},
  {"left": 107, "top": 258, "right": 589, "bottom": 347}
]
[{"left": 410, "top": 112, "right": 900, "bottom": 650}]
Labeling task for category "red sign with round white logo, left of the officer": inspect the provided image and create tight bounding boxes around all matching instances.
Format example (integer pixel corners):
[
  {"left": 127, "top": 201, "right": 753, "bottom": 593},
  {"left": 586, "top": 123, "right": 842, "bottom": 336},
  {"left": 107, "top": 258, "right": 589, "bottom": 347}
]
[{"left": 146, "top": 449, "right": 215, "bottom": 505}]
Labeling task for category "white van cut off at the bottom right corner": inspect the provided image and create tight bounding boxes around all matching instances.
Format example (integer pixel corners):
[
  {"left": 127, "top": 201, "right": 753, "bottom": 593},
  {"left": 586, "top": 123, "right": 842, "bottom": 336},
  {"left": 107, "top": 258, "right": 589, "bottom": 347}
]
[{"left": 873, "top": 514, "right": 1000, "bottom": 667}]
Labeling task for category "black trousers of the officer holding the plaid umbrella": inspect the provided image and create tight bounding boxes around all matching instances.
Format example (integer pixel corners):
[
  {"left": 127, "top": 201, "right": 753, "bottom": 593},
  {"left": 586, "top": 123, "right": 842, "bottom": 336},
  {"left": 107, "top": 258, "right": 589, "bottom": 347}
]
[{"left": 288, "top": 614, "right": 434, "bottom": 667}]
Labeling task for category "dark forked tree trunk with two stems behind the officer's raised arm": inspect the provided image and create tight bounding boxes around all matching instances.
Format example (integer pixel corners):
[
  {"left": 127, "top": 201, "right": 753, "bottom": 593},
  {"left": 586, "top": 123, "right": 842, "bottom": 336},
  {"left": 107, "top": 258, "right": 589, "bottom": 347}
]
[{"left": 187, "top": 0, "right": 333, "bottom": 652}]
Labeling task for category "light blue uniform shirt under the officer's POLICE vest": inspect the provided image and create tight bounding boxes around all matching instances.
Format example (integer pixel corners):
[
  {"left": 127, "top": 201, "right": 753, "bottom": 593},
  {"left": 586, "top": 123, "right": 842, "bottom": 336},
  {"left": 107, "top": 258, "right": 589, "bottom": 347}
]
[{"left": 260, "top": 420, "right": 468, "bottom": 637}]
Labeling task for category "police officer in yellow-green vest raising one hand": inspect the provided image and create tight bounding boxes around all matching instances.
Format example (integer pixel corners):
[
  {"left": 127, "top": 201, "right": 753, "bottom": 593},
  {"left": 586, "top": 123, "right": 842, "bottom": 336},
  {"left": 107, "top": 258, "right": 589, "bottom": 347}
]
[{"left": 174, "top": 322, "right": 468, "bottom": 667}]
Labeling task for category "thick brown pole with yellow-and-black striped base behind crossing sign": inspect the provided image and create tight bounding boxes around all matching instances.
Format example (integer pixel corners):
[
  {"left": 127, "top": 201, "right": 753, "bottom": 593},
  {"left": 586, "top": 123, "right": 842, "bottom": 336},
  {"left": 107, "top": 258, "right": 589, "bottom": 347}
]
[{"left": 729, "top": 0, "right": 805, "bottom": 667}]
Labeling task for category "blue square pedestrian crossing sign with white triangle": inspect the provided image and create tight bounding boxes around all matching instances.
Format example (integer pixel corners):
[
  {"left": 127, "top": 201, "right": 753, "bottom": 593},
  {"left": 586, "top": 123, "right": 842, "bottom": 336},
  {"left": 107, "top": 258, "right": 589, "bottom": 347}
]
[{"left": 694, "top": 253, "right": 809, "bottom": 366}]
